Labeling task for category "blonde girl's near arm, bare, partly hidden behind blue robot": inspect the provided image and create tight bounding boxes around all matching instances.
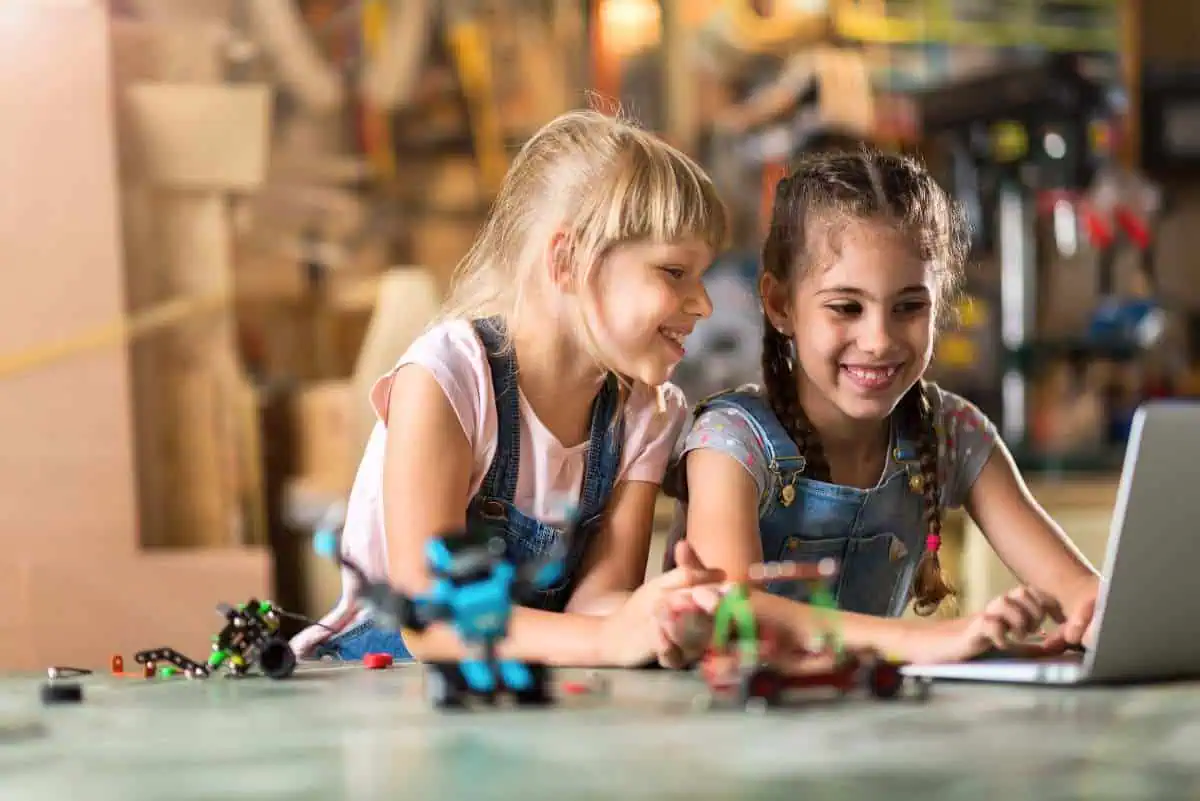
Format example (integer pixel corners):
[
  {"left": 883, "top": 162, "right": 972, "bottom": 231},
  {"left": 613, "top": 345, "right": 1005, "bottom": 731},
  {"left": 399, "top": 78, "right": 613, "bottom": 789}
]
[{"left": 383, "top": 365, "right": 604, "bottom": 666}]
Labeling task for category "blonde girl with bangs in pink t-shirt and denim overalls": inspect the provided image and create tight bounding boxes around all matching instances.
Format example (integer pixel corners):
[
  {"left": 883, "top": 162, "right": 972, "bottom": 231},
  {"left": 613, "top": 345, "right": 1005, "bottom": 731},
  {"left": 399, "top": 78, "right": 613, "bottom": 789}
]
[{"left": 293, "top": 112, "right": 726, "bottom": 666}]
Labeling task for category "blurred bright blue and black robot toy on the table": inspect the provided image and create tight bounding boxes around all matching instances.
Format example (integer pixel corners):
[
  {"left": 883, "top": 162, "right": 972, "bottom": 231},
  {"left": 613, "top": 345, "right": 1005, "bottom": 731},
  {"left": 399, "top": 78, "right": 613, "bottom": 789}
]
[{"left": 314, "top": 528, "right": 563, "bottom": 709}]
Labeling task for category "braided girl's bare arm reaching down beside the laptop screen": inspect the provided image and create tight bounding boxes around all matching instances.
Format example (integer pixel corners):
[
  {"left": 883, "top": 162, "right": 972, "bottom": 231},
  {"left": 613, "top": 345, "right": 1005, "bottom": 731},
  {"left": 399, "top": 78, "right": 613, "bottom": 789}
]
[{"left": 965, "top": 440, "right": 1099, "bottom": 625}]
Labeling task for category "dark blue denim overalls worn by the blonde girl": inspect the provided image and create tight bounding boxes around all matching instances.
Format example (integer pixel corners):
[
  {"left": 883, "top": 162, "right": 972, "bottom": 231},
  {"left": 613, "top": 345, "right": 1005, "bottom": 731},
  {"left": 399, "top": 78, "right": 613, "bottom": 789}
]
[{"left": 313, "top": 320, "right": 624, "bottom": 660}]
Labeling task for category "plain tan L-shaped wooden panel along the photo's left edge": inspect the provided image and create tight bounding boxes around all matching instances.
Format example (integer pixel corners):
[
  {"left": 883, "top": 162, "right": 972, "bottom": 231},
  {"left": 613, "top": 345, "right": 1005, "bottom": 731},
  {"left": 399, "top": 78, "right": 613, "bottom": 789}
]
[{"left": 0, "top": 4, "right": 270, "bottom": 669}]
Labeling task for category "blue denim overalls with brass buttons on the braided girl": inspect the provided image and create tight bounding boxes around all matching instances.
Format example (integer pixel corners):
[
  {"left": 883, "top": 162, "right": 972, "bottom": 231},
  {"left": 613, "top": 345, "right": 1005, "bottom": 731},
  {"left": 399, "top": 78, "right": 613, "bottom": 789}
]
[{"left": 681, "top": 391, "right": 926, "bottom": 616}]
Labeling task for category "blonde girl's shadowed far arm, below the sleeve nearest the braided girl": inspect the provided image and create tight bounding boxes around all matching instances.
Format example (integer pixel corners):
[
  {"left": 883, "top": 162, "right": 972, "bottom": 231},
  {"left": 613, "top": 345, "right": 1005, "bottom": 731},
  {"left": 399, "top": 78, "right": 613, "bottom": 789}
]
[{"left": 566, "top": 481, "right": 659, "bottom": 615}]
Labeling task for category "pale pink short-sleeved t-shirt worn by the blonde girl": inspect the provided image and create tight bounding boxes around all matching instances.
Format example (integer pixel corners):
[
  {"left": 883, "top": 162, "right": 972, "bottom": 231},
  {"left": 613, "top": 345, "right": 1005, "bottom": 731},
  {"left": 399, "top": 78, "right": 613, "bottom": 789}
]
[{"left": 292, "top": 320, "right": 688, "bottom": 655}]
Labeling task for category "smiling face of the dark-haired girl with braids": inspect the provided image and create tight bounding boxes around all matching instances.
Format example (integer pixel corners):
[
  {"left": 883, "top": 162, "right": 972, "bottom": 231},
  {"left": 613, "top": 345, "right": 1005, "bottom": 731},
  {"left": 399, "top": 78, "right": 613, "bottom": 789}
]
[{"left": 762, "top": 215, "right": 937, "bottom": 421}]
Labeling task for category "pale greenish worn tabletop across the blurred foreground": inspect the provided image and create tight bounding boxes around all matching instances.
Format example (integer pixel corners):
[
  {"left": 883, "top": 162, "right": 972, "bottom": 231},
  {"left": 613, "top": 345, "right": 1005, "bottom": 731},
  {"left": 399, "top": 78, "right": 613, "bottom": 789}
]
[{"left": 0, "top": 663, "right": 1200, "bottom": 801}]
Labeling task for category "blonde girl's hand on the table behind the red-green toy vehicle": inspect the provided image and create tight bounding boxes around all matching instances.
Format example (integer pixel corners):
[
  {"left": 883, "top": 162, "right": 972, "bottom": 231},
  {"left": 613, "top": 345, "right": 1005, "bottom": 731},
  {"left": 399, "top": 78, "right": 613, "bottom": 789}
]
[{"left": 600, "top": 541, "right": 722, "bottom": 668}]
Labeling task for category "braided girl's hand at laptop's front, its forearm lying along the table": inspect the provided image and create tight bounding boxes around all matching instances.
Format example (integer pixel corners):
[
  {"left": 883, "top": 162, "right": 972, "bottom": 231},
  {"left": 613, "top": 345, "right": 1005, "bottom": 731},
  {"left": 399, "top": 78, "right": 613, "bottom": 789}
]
[{"left": 906, "top": 586, "right": 1066, "bottom": 662}]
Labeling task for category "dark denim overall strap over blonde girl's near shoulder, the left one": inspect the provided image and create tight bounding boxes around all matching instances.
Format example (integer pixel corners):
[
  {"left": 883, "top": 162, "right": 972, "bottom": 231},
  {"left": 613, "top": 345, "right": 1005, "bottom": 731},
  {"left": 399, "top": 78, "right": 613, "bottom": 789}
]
[{"left": 473, "top": 318, "right": 521, "bottom": 501}]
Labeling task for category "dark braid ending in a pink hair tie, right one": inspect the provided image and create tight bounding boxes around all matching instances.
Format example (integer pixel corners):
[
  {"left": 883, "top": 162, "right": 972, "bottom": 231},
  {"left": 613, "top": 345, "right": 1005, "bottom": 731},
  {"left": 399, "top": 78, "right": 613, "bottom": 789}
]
[{"left": 901, "top": 380, "right": 955, "bottom": 616}]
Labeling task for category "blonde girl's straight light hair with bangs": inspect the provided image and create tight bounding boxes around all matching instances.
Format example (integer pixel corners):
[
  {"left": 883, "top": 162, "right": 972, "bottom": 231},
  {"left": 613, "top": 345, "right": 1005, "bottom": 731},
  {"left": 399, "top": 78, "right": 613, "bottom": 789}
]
[{"left": 439, "top": 110, "right": 728, "bottom": 367}]
